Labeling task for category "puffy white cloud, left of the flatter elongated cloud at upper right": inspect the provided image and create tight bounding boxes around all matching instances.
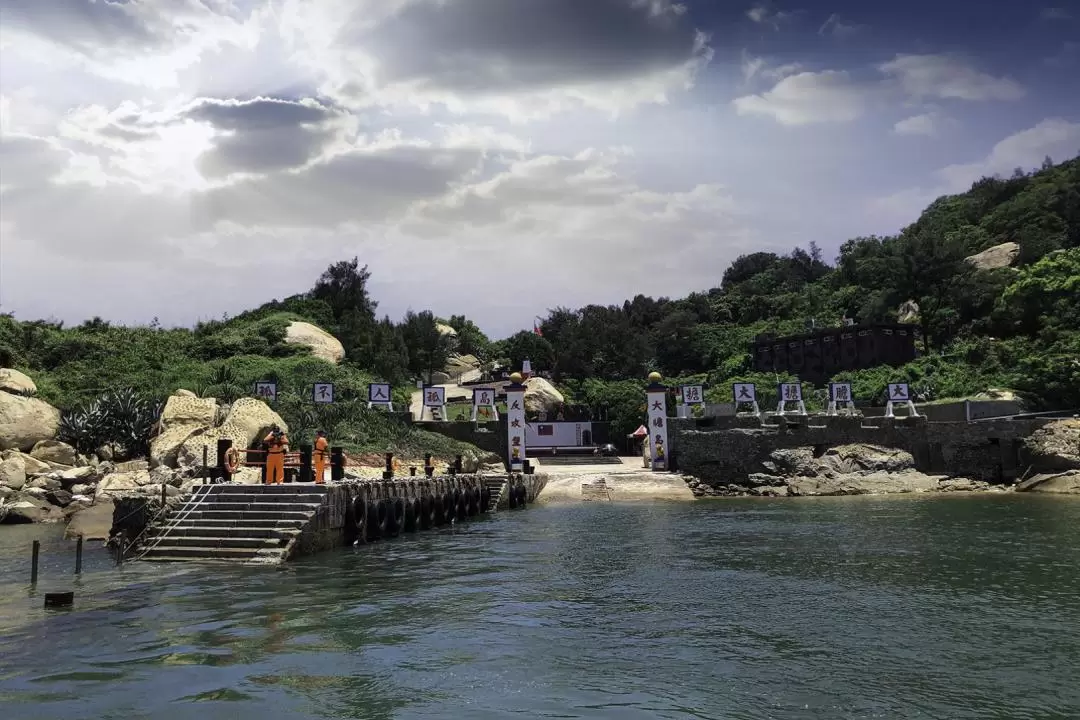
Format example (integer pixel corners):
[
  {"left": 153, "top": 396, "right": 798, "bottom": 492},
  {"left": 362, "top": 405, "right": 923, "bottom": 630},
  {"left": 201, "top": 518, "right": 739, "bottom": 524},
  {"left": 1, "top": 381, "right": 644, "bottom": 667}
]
[{"left": 734, "top": 70, "right": 866, "bottom": 125}]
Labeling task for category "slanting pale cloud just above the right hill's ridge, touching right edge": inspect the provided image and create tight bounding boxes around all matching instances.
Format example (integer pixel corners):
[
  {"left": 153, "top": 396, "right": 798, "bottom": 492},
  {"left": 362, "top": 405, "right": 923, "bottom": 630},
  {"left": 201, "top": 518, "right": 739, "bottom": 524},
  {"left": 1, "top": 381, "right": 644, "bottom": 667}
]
[{"left": 867, "top": 118, "right": 1080, "bottom": 232}]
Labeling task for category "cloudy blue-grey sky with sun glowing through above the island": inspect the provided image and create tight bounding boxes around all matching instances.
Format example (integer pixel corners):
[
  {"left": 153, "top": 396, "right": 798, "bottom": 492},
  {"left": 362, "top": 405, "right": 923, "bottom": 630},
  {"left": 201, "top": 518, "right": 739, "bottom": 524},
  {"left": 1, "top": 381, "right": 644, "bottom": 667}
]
[{"left": 0, "top": 0, "right": 1080, "bottom": 338}]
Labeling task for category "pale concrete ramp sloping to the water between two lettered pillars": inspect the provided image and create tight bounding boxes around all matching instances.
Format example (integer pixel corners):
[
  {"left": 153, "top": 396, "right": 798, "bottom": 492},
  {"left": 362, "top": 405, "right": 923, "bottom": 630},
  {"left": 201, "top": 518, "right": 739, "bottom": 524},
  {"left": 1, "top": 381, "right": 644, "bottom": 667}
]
[{"left": 536, "top": 458, "right": 694, "bottom": 503}]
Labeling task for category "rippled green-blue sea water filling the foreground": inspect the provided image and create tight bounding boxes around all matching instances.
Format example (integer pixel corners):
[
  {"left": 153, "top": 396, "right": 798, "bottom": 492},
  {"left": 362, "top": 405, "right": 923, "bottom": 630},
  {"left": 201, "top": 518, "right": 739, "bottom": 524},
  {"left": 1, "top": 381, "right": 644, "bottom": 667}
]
[{"left": 0, "top": 495, "right": 1080, "bottom": 720}]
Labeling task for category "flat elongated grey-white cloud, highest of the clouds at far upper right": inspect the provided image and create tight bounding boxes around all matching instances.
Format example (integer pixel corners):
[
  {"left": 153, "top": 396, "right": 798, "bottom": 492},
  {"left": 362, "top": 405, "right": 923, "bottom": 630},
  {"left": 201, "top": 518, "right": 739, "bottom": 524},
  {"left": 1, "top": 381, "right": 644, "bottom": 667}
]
[{"left": 879, "top": 55, "right": 1025, "bottom": 100}]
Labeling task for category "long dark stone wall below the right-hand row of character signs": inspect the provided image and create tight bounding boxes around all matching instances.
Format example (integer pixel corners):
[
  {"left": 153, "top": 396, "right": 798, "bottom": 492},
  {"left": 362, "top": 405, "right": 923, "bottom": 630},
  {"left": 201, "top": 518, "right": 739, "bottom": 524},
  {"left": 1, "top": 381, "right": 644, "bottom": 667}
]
[{"left": 670, "top": 416, "right": 1052, "bottom": 484}]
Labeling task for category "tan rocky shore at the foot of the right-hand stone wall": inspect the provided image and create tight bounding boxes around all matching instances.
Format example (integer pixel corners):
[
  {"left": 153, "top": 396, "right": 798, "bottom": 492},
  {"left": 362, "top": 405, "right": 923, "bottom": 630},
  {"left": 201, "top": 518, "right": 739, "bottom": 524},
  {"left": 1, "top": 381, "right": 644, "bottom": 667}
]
[{"left": 687, "top": 419, "right": 1080, "bottom": 498}]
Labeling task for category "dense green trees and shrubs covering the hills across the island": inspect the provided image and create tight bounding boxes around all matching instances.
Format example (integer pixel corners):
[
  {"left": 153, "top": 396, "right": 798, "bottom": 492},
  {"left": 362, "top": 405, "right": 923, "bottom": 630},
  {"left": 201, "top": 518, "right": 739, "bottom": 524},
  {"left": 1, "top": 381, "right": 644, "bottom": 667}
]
[{"left": 0, "top": 158, "right": 1080, "bottom": 452}]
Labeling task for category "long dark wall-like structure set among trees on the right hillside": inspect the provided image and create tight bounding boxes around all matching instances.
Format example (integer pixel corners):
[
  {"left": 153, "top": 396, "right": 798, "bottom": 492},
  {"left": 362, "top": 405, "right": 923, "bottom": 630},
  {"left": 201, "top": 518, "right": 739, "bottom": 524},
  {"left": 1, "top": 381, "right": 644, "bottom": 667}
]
[{"left": 751, "top": 323, "right": 921, "bottom": 384}]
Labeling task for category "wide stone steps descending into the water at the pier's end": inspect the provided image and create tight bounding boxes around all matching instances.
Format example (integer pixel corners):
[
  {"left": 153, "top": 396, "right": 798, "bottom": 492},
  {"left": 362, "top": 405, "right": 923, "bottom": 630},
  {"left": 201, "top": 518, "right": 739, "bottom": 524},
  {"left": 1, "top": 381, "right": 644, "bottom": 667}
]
[{"left": 138, "top": 484, "right": 327, "bottom": 562}]
